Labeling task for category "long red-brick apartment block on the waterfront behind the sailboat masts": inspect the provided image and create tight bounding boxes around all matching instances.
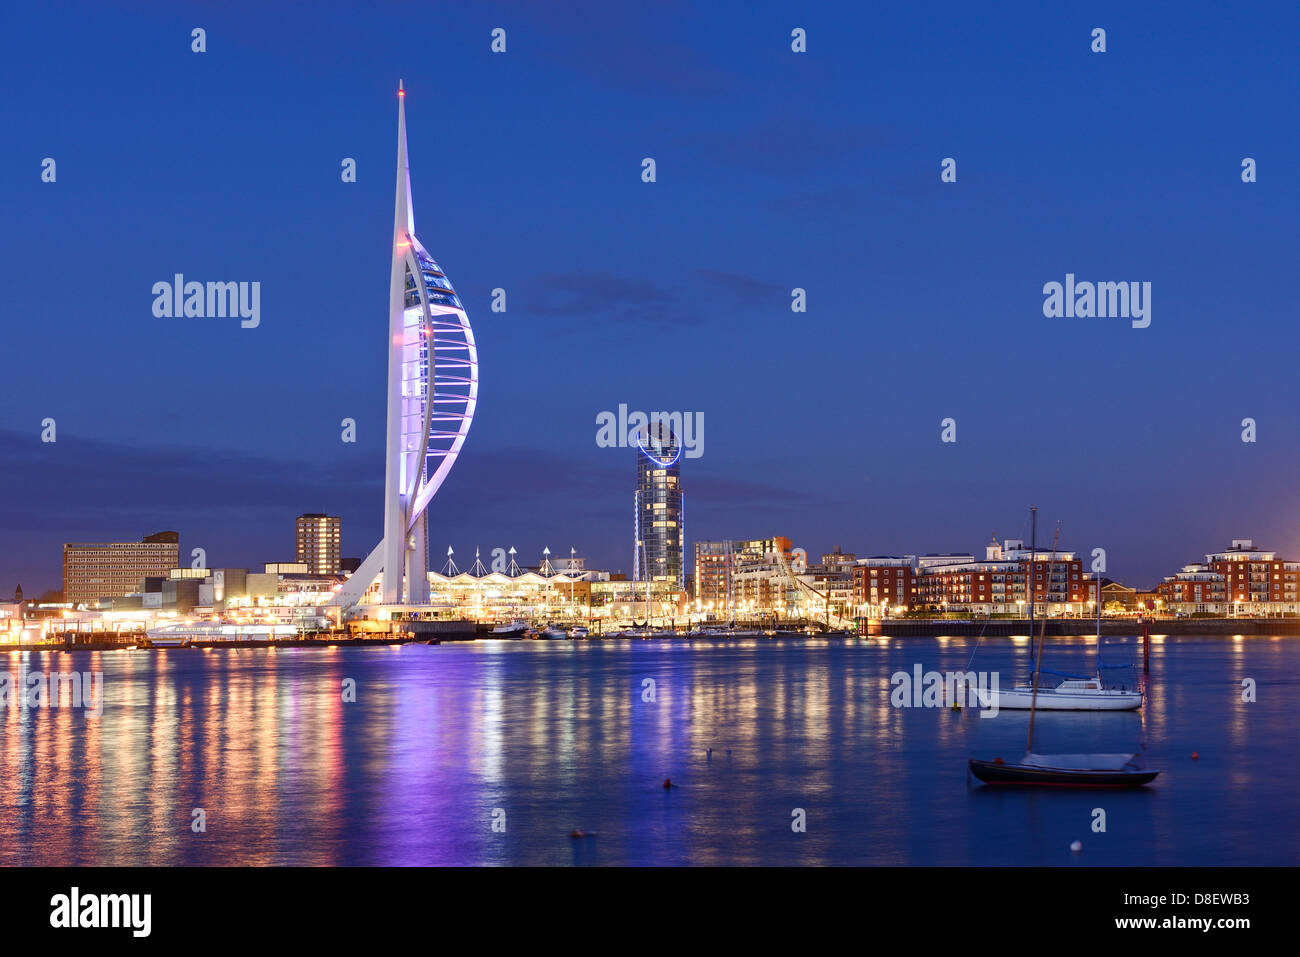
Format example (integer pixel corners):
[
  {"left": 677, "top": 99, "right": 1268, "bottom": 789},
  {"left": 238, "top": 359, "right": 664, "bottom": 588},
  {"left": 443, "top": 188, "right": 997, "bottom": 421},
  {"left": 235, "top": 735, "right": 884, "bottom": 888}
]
[{"left": 917, "top": 538, "right": 1088, "bottom": 615}]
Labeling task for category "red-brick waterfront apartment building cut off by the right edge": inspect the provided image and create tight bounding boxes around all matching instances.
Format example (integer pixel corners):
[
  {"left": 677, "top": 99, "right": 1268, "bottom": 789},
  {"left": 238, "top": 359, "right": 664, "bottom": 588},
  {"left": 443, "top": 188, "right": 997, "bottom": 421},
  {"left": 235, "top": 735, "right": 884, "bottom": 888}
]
[{"left": 1156, "top": 538, "right": 1300, "bottom": 616}]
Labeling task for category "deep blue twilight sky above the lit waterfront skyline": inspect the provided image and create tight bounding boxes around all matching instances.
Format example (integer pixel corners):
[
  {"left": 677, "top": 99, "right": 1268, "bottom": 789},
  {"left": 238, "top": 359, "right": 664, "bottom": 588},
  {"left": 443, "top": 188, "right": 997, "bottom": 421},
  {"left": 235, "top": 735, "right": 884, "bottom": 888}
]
[{"left": 0, "top": 0, "right": 1300, "bottom": 593}]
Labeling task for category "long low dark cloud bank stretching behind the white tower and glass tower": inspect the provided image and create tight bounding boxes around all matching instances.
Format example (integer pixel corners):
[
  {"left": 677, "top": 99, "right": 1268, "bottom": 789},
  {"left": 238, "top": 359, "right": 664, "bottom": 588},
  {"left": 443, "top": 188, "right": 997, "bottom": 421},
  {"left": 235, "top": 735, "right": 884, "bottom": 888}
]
[{"left": 0, "top": 421, "right": 818, "bottom": 593}]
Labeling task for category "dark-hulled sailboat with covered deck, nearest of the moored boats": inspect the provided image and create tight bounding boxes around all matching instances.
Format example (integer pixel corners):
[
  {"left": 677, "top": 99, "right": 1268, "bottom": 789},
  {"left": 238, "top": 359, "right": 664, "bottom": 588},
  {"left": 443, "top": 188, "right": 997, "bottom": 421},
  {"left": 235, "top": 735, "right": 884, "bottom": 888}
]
[{"left": 967, "top": 528, "right": 1160, "bottom": 788}]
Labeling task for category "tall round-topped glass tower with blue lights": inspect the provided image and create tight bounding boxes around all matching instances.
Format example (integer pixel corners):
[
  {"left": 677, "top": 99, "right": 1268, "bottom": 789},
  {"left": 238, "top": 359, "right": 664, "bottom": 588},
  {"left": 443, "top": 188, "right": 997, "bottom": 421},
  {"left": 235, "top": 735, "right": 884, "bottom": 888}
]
[{"left": 632, "top": 421, "right": 685, "bottom": 589}]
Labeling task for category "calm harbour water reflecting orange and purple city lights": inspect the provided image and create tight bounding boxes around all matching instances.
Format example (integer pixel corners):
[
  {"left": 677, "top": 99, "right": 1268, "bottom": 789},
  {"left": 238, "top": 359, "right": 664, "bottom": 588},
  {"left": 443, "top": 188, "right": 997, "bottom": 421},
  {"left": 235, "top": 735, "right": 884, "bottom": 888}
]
[{"left": 0, "top": 637, "right": 1300, "bottom": 865}]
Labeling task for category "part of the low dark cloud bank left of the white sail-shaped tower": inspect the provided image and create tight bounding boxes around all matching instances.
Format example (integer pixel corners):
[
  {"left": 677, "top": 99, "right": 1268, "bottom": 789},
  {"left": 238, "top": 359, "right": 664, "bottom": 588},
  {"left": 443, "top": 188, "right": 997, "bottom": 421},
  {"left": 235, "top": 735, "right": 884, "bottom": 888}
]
[{"left": 0, "top": 430, "right": 384, "bottom": 592}]
